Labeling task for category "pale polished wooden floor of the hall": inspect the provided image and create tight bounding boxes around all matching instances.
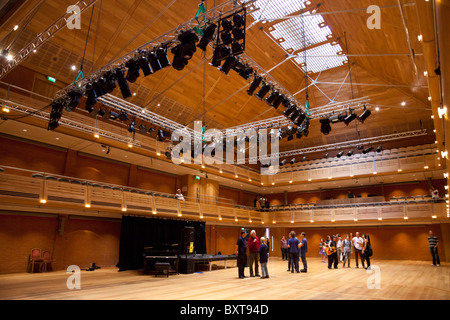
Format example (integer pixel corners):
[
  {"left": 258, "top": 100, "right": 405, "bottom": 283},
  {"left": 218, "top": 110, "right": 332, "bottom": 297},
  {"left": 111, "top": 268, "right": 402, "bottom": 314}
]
[{"left": 0, "top": 258, "right": 450, "bottom": 300}]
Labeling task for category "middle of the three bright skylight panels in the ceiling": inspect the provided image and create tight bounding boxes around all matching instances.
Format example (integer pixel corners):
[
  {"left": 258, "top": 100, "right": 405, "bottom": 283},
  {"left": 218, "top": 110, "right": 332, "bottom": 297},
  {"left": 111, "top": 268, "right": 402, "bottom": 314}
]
[{"left": 270, "top": 12, "right": 332, "bottom": 52}]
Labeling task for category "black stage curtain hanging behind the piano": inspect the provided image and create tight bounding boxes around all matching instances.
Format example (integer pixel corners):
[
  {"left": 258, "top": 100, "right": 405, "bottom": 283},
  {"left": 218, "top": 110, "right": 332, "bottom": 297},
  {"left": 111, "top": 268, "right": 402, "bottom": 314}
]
[{"left": 117, "top": 216, "right": 206, "bottom": 271}]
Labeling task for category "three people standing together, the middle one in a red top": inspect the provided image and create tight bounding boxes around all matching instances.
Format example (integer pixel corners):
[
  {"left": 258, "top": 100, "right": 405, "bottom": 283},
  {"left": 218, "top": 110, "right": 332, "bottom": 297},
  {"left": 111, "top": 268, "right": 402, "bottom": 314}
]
[{"left": 236, "top": 229, "right": 269, "bottom": 279}]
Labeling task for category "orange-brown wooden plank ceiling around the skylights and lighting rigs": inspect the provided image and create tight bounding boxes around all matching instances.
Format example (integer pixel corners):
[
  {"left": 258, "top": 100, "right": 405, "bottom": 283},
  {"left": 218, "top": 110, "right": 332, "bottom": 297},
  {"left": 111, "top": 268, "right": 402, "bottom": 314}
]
[{"left": 0, "top": 0, "right": 433, "bottom": 155}]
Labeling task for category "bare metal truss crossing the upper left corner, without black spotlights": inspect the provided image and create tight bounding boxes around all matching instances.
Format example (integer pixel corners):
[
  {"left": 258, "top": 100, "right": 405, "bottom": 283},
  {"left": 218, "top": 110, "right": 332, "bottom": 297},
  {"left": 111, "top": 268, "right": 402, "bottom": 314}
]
[{"left": 0, "top": 0, "right": 98, "bottom": 79}]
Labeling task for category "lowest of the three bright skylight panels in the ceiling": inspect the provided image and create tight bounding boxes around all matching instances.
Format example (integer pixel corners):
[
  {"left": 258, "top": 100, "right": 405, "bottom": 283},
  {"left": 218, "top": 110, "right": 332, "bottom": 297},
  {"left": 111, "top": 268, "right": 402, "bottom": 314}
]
[{"left": 294, "top": 43, "right": 347, "bottom": 73}]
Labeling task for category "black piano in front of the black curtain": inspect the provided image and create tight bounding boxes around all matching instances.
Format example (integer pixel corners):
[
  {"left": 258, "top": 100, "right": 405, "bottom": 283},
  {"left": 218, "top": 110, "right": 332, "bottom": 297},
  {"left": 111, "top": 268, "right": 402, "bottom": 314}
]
[{"left": 144, "top": 244, "right": 180, "bottom": 276}]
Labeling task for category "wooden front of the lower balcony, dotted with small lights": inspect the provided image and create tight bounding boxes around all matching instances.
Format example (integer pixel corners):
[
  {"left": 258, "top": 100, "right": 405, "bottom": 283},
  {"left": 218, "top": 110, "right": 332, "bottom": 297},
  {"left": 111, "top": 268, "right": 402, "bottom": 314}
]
[{"left": 0, "top": 166, "right": 449, "bottom": 225}]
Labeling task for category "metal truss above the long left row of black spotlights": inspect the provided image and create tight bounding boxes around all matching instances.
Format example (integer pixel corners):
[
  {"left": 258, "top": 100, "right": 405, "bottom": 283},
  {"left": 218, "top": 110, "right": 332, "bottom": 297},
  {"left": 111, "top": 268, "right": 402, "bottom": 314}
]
[{"left": 55, "top": 0, "right": 256, "bottom": 100}]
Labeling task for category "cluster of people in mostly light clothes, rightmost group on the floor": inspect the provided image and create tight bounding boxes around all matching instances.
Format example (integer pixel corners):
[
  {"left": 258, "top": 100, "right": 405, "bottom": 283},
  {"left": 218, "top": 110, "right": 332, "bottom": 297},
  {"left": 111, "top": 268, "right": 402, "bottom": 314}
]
[{"left": 319, "top": 232, "right": 373, "bottom": 270}]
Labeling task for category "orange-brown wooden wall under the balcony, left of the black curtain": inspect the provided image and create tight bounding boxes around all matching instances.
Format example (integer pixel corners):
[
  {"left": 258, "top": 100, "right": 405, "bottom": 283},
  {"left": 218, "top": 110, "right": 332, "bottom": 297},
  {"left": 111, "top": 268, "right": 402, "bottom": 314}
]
[{"left": 0, "top": 214, "right": 121, "bottom": 274}]
